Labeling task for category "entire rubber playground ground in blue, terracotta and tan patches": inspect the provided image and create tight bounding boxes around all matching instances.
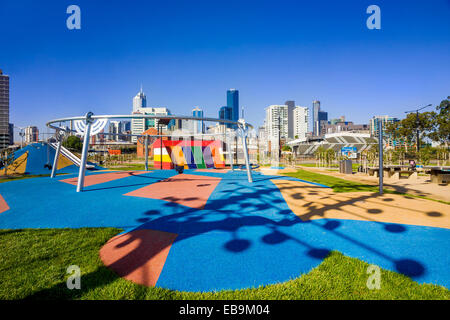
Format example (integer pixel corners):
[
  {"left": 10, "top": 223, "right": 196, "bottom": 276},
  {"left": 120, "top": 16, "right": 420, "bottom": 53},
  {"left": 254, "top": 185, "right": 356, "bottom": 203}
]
[{"left": 0, "top": 169, "right": 450, "bottom": 291}]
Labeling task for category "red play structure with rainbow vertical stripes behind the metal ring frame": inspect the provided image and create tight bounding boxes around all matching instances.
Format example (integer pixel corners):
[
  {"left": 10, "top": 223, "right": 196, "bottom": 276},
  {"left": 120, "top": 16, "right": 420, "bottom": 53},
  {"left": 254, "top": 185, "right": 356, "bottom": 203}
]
[{"left": 151, "top": 139, "right": 225, "bottom": 169}]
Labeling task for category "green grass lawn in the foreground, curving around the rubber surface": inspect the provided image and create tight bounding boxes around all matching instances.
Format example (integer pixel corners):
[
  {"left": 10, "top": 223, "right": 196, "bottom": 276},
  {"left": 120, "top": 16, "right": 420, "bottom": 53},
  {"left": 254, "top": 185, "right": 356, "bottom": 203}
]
[{"left": 0, "top": 228, "right": 450, "bottom": 300}]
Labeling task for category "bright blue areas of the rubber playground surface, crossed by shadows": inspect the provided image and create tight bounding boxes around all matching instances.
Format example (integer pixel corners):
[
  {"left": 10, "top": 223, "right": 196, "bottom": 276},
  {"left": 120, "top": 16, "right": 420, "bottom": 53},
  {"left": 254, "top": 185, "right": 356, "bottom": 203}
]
[{"left": 0, "top": 170, "right": 450, "bottom": 291}]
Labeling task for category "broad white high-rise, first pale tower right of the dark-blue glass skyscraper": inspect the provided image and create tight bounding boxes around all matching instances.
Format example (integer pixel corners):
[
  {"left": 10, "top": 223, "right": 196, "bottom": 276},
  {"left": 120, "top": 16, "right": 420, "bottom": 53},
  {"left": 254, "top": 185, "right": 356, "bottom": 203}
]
[{"left": 266, "top": 105, "right": 289, "bottom": 141}]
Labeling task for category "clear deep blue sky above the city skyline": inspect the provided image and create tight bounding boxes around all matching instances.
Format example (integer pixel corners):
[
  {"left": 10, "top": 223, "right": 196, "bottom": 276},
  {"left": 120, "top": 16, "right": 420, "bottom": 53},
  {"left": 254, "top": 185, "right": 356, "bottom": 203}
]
[{"left": 0, "top": 0, "right": 450, "bottom": 139}]
